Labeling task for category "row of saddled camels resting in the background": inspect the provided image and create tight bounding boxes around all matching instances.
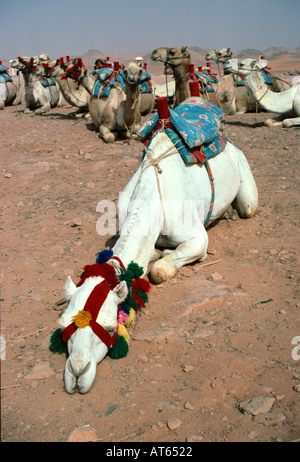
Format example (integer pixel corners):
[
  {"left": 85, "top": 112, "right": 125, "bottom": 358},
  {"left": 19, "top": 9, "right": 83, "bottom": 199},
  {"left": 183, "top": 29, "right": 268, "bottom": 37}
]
[{"left": 2, "top": 47, "right": 300, "bottom": 134}]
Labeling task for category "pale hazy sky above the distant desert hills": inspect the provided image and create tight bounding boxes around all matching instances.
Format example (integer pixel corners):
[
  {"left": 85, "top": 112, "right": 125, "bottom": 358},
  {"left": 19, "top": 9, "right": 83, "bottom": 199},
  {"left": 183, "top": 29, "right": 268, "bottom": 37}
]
[{"left": 0, "top": 0, "right": 300, "bottom": 59}]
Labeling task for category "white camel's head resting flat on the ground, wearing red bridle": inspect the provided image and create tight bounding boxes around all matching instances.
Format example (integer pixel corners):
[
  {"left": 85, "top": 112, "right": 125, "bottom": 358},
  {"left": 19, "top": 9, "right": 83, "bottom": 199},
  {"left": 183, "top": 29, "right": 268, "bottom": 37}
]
[{"left": 58, "top": 276, "right": 128, "bottom": 393}]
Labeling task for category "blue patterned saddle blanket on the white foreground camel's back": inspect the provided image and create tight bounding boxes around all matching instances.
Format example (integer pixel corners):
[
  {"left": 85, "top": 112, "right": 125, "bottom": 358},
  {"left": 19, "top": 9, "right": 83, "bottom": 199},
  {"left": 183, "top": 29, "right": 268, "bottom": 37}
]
[{"left": 139, "top": 97, "right": 227, "bottom": 164}]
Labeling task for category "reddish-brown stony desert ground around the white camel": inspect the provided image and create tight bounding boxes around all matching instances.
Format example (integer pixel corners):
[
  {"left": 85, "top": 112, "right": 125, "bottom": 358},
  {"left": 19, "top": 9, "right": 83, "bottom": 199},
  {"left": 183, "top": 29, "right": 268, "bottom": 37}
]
[{"left": 0, "top": 87, "right": 300, "bottom": 442}]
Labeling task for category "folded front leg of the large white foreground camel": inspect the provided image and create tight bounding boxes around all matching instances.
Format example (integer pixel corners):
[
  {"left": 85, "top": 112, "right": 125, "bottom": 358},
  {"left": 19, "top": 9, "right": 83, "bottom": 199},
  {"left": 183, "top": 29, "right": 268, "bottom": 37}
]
[{"left": 150, "top": 223, "right": 208, "bottom": 284}]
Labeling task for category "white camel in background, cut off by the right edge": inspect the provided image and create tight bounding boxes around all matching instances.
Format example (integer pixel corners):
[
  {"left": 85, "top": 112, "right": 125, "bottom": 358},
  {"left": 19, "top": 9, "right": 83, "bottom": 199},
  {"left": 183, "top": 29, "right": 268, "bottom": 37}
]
[{"left": 224, "top": 58, "right": 300, "bottom": 128}]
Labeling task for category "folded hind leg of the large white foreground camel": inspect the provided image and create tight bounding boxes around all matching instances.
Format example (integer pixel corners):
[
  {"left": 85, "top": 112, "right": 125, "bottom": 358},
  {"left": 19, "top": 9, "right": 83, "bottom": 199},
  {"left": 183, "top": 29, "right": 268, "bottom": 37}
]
[{"left": 232, "top": 151, "right": 258, "bottom": 218}]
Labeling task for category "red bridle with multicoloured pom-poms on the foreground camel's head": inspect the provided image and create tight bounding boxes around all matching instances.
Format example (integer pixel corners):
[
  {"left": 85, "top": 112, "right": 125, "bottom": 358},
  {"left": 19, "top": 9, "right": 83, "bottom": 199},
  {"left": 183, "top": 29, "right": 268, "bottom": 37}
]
[{"left": 50, "top": 249, "right": 151, "bottom": 359}]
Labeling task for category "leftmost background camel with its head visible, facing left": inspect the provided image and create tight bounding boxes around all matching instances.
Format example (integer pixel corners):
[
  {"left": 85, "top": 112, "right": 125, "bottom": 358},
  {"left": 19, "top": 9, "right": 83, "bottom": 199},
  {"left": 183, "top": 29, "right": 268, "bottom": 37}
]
[{"left": 10, "top": 57, "right": 61, "bottom": 115}]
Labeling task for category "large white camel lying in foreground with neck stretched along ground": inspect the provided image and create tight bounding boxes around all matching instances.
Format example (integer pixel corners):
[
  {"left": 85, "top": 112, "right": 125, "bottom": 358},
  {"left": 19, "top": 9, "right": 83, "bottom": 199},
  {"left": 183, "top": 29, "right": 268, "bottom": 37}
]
[{"left": 55, "top": 98, "right": 258, "bottom": 393}]
